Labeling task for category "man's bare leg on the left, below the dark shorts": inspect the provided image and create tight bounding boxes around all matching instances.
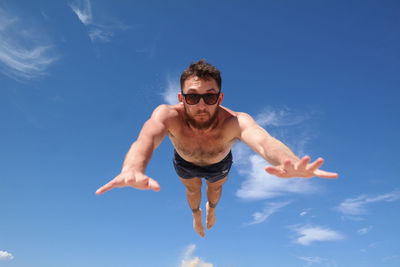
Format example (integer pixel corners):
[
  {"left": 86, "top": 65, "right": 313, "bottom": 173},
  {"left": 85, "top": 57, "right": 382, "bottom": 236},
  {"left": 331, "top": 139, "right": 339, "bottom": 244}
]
[{"left": 180, "top": 177, "right": 205, "bottom": 237}]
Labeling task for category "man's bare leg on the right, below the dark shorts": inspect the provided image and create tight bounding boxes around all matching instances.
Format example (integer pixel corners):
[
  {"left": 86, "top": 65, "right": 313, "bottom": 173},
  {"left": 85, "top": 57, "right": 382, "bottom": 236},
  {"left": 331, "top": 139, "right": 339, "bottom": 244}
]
[{"left": 206, "top": 176, "right": 228, "bottom": 229}]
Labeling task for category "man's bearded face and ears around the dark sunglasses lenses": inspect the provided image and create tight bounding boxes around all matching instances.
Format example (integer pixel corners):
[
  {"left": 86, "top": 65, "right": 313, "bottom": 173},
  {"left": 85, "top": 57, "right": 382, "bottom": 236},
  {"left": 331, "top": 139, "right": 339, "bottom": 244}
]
[{"left": 178, "top": 76, "right": 223, "bottom": 130}]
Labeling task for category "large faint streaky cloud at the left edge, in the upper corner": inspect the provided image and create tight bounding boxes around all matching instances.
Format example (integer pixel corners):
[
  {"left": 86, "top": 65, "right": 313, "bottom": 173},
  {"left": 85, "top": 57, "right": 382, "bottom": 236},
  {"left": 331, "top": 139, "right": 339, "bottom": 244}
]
[{"left": 0, "top": 7, "right": 58, "bottom": 81}]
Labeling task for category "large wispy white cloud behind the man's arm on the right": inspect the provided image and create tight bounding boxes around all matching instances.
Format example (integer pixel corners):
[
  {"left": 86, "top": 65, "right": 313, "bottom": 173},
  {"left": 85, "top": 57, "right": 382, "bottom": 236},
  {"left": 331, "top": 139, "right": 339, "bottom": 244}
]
[{"left": 234, "top": 108, "right": 320, "bottom": 200}]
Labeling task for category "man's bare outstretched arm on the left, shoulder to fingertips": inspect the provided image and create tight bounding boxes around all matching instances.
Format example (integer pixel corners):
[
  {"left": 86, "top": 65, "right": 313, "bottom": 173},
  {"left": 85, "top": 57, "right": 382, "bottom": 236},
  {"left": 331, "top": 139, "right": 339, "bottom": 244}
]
[{"left": 96, "top": 105, "right": 174, "bottom": 194}]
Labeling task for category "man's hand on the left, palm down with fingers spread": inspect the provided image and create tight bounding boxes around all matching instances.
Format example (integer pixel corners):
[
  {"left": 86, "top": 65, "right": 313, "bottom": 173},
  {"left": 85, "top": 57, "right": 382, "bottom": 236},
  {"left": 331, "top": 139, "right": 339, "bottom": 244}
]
[{"left": 96, "top": 171, "right": 160, "bottom": 195}]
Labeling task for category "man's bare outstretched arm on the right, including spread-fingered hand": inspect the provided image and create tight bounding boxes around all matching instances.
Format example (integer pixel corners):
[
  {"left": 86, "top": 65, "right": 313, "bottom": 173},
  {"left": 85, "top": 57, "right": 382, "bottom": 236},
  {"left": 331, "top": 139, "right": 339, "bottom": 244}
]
[{"left": 237, "top": 113, "right": 338, "bottom": 178}]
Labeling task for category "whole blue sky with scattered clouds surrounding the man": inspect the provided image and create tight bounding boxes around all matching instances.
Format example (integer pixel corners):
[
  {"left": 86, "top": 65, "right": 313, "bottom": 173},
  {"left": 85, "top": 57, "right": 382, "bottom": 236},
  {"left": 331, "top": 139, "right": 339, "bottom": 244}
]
[{"left": 0, "top": 0, "right": 400, "bottom": 267}]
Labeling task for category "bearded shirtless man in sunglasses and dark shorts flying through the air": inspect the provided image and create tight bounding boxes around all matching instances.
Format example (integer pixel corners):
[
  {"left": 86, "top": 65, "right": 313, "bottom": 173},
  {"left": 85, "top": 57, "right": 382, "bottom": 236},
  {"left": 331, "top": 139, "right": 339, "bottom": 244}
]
[{"left": 96, "top": 60, "right": 338, "bottom": 237}]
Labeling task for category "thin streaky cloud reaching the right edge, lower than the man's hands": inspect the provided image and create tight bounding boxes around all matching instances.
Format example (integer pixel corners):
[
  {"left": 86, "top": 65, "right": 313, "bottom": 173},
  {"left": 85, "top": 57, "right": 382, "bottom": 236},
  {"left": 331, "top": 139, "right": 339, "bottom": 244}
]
[{"left": 335, "top": 190, "right": 400, "bottom": 220}]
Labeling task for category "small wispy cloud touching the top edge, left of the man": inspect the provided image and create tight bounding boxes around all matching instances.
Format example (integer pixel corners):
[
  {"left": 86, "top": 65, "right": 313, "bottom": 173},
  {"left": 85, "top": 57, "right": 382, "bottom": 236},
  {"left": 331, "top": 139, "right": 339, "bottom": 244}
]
[{"left": 69, "top": 0, "right": 128, "bottom": 42}]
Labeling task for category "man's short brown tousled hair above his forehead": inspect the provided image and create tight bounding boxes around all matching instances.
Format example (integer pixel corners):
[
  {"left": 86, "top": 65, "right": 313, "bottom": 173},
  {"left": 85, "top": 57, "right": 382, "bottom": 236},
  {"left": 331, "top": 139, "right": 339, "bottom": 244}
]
[{"left": 181, "top": 59, "right": 222, "bottom": 91}]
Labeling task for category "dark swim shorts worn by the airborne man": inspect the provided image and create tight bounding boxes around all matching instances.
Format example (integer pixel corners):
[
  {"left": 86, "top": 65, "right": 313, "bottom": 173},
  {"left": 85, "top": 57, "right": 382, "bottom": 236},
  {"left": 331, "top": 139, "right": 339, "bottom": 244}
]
[{"left": 174, "top": 150, "right": 232, "bottom": 183}]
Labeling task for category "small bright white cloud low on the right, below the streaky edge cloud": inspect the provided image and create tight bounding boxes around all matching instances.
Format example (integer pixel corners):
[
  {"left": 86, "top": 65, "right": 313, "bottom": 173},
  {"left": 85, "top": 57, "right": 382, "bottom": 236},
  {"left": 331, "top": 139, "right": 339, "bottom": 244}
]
[{"left": 289, "top": 225, "right": 344, "bottom": 246}]
